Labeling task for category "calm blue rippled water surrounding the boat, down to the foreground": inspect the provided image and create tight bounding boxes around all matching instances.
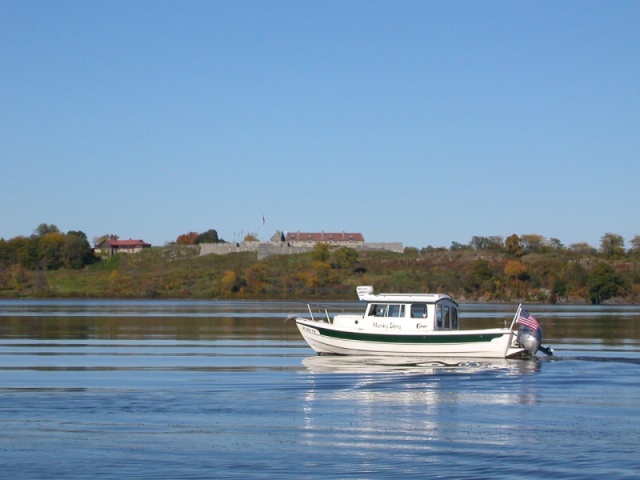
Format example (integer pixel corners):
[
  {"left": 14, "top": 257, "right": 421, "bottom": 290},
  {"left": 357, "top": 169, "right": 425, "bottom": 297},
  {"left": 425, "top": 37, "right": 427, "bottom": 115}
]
[{"left": 0, "top": 301, "right": 640, "bottom": 479}]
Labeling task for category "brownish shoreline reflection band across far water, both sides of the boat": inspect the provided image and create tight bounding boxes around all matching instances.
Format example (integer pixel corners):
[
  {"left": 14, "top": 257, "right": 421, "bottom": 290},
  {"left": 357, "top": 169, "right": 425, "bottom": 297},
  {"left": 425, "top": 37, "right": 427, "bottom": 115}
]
[{"left": 0, "top": 300, "right": 640, "bottom": 350}]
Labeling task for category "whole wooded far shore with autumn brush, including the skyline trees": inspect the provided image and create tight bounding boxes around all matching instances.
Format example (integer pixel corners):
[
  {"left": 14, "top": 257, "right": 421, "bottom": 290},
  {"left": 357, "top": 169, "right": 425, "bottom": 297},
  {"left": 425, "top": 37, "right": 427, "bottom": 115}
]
[{"left": 0, "top": 224, "right": 640, "bottom": 304}]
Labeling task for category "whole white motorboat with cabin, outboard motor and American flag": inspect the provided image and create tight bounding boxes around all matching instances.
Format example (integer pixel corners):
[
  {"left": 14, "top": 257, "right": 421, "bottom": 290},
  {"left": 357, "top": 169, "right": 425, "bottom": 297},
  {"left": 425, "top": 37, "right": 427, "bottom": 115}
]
[{"left": 289, "top": 286, "right": 552, "bottom": 358}]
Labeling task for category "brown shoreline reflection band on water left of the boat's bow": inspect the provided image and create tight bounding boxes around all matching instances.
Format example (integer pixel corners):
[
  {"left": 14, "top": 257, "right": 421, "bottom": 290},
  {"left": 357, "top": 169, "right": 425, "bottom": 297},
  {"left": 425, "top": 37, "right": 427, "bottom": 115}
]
[{"left": 0, "top": 300, "right": 299, "bottom": 341}]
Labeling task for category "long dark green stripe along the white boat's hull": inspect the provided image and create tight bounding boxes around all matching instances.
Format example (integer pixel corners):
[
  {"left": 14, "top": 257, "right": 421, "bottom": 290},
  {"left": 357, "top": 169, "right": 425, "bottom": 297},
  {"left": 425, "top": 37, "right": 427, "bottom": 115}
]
[{"left": 310, "top": 324, "right": 504, "bottom": 344}]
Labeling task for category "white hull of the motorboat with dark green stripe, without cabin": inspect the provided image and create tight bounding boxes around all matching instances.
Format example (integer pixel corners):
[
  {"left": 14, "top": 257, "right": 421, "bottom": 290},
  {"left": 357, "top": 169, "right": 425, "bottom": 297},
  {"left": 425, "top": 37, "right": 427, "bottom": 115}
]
[{"left": 296, "top": 317, "right": 525, "bottom": 358}]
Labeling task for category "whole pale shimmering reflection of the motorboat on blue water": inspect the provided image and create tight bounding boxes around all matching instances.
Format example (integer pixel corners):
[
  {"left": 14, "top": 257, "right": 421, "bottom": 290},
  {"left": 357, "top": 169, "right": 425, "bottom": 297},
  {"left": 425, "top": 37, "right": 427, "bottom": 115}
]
[{"left": 301, "top": 356, "right": 543, "bottom": 448}]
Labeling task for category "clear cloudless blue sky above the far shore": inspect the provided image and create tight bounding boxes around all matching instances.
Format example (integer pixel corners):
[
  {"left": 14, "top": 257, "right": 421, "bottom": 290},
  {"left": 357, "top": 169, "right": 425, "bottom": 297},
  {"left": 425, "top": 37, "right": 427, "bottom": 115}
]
[{"left": 0, "top": 0, "right": 640, "bottom": 248}]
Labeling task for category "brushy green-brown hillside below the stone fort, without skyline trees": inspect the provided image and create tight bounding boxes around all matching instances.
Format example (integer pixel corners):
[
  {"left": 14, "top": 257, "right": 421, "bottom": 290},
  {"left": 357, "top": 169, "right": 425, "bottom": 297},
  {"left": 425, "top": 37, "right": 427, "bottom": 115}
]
[{"left": 0, "top": 245, "right": 640, "bottom": 303}]
